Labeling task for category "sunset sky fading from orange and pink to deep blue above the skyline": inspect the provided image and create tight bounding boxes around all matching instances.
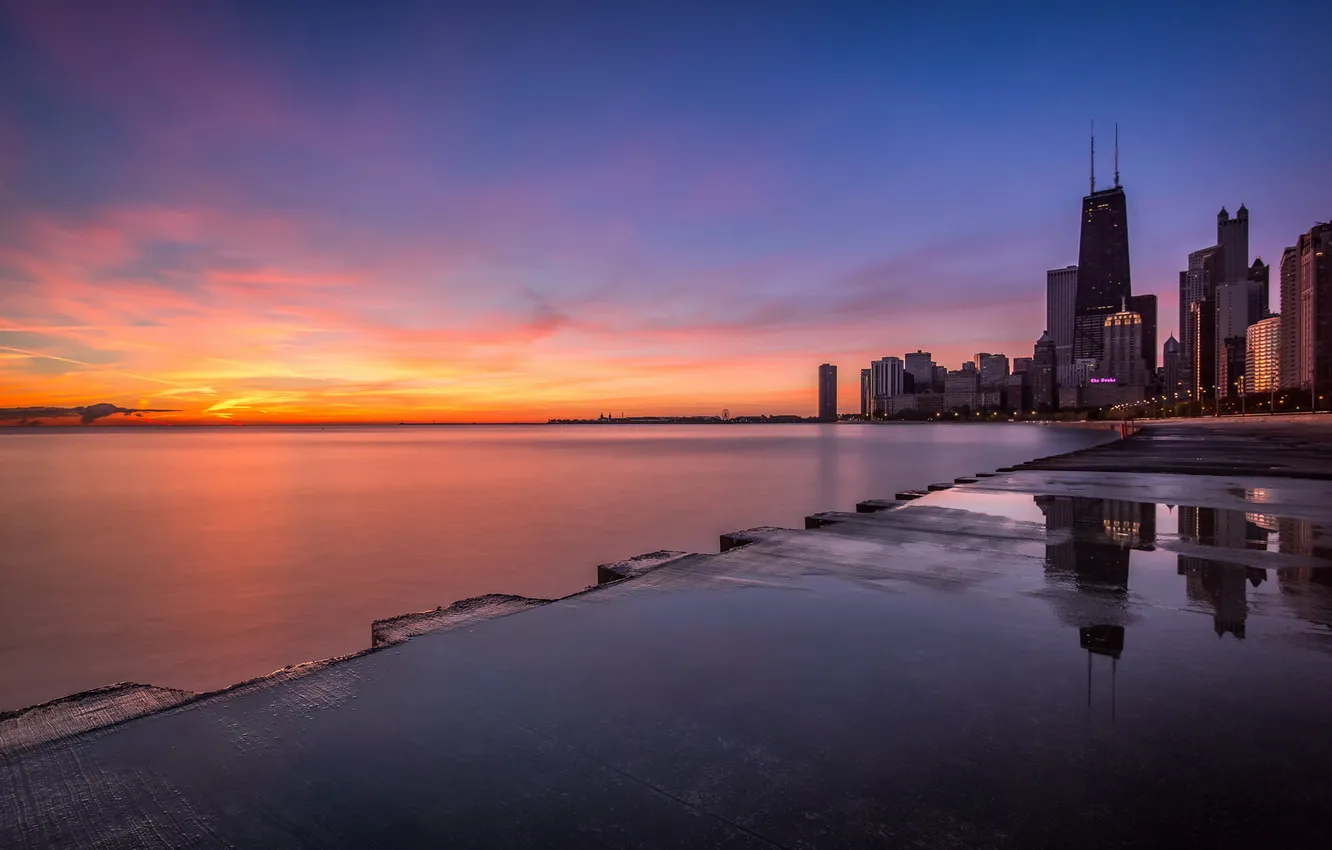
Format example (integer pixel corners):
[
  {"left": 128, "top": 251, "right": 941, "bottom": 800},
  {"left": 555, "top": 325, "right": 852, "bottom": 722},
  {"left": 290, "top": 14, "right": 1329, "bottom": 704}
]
[{"left": 0, "top": 0, "right": 1332, "bottom": 422}]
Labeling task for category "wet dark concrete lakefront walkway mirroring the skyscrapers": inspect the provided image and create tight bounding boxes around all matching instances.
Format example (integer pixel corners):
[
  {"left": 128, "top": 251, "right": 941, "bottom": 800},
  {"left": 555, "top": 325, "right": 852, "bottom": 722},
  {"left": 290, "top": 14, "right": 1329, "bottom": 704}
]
[{"left": 0, "top": 421, "right": 1332, "bottom": 847}]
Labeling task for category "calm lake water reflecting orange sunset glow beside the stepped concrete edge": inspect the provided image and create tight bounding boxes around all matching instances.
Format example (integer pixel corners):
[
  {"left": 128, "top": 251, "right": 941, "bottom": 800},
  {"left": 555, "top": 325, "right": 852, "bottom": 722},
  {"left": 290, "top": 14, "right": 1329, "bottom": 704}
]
[{"left": 0, "top": 425, "right": 1111, "bottom": 709}]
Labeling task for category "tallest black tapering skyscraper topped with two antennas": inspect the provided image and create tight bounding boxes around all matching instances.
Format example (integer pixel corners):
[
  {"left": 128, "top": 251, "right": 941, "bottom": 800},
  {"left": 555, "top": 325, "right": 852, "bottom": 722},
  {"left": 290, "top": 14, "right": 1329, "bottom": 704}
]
[{"left": 1074, "top": 132, "right": 1134, "bottom": 361}]
